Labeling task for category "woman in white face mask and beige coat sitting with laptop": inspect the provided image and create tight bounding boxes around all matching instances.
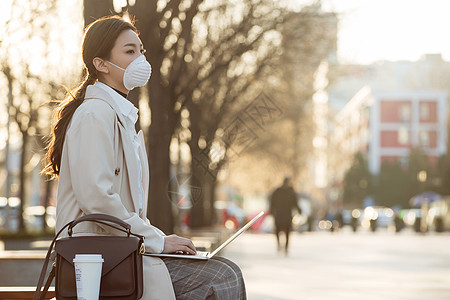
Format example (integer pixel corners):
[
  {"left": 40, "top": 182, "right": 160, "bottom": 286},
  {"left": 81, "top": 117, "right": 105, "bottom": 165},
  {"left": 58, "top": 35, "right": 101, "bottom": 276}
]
[{"left": 44, "top": 16, "right": 246, "bottom": 300}]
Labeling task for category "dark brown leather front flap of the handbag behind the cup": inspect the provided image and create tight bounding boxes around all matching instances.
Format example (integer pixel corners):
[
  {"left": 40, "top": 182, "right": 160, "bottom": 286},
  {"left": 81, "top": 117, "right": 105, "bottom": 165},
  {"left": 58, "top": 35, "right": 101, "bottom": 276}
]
[{"left": 55, "top": 236, "right": 140, "bottom": 276}]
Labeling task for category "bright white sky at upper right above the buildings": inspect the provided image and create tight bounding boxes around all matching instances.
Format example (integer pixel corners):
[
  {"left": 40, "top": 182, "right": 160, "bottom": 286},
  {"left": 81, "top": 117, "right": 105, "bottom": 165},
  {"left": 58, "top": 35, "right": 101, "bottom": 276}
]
[{"left": 323, "top": 0, "right": 450, "bottom": 64}]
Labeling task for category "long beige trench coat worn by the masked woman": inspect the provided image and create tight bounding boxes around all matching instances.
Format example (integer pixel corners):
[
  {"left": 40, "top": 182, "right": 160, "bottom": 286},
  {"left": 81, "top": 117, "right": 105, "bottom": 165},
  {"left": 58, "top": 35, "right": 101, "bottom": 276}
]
[{"left": 56, "top": 85, "right": 175, "bottom": 300}]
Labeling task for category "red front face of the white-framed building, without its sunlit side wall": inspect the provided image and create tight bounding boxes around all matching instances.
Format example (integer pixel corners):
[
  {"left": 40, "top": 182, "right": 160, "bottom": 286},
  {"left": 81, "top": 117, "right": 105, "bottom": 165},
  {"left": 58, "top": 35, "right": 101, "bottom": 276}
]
[{"left": 368, "top": 90, "right": 447, "bottom": 173}]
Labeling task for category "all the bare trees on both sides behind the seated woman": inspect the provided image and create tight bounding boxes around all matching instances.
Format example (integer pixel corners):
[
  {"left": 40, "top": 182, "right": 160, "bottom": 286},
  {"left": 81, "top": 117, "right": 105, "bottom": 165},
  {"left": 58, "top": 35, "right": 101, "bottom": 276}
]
[{"left": 1, "top": 0, "right": 336, "bottom": 232}]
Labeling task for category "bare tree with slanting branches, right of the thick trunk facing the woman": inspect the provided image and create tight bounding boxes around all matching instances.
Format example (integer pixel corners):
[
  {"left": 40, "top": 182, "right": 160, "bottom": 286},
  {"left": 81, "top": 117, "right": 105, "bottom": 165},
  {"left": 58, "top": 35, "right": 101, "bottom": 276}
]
[{"left": 186, "top": 1, "right": 289, "bottom": 227}]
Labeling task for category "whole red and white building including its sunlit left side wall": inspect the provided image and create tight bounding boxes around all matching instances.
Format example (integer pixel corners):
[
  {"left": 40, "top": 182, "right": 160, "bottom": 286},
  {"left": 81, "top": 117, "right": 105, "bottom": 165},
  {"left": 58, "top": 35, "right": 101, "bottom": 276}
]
[{"left": 329, "top": 86, "right": 448, "bottom": 183}]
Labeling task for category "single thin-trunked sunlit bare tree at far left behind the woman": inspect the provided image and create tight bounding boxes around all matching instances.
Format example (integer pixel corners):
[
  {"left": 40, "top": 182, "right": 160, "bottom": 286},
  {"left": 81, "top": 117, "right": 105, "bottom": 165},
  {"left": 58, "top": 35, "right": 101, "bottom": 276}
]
[{"left": 0, "top": 0, "right": 69, "bottom": 231}]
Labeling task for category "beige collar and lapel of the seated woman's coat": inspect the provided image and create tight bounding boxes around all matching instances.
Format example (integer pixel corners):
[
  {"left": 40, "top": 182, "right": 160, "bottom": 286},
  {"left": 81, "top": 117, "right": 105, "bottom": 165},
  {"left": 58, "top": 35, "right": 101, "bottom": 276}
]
[{"left": 85, "top": 85, "right": 141, "bottom": 213}]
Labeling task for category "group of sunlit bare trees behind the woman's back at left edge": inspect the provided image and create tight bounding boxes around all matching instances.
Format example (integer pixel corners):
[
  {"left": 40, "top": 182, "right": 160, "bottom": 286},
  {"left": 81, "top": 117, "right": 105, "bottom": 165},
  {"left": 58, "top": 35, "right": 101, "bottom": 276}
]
[{"left": 0, "top": 0, "right": 75, "bottom": 231}]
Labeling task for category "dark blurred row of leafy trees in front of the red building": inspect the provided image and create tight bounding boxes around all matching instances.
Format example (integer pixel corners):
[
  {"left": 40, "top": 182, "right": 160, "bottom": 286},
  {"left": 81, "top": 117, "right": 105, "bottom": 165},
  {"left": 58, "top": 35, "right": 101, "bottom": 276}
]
[{"left": 343, "top": 149, "right": 450, "bottom": 208}]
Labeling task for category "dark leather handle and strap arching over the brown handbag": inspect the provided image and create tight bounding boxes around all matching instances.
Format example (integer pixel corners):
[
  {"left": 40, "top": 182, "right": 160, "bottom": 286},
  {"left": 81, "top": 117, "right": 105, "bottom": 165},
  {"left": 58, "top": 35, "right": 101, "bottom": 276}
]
[{"left": 33, "top": 214, "right": 145, "bottom": 300}]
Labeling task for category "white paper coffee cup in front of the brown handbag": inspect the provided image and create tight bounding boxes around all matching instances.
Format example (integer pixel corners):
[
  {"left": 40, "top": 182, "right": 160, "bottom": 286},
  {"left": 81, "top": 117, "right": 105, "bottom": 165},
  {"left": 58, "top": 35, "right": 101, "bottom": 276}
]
[{"left": 73, "top": 254, "right": 104, "bottom": 300}]
